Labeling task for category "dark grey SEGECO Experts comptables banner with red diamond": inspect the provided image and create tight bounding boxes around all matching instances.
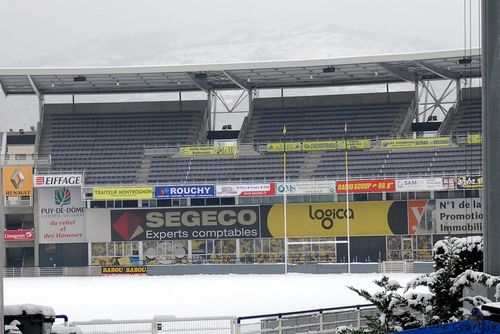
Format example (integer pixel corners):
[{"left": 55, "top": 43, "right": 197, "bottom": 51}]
[{"left": 111, "top": 206, "right": 261, "bottom": 241}]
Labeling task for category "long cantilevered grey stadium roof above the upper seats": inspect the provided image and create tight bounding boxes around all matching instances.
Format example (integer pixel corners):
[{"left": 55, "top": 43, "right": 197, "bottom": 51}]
[{"left": 0, "top": 48, "right": 481, "bottom": 95}]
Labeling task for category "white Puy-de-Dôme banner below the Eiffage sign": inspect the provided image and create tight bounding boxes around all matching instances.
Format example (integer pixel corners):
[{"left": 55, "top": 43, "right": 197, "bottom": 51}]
[{"left": 38, "top": 187, "right": 87, "bottom": 243}]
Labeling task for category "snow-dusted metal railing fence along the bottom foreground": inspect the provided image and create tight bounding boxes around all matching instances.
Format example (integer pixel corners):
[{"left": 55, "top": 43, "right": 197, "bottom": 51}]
[{"left": 54, "top": 304, "right": 376, "bottom": 334}]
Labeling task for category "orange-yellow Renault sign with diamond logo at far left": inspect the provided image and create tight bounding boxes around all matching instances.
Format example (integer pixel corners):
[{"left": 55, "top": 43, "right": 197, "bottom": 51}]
[{"left": 3, "top": 166, "right": 33, "bottom": 197}]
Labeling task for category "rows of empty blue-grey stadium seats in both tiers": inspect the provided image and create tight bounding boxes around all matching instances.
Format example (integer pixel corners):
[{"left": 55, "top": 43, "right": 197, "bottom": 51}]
[{"left": 39, "top": 92, "right": 481, "bottom": 185}]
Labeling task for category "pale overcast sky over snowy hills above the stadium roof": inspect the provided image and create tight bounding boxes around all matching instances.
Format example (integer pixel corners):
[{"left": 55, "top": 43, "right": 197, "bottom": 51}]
[{"left": 0, "top": 0, "right": 479, "bottom": 131}]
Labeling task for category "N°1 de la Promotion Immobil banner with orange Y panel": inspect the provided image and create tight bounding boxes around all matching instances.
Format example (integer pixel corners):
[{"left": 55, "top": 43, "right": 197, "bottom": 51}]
[{"left": 408, "top": 198, "right": 483, "bottom": 235}]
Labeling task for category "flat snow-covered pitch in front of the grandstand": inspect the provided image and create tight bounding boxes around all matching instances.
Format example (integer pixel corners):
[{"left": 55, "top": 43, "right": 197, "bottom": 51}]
[{"left": 4, "top": 274, "right": 416, "bottom": 321}]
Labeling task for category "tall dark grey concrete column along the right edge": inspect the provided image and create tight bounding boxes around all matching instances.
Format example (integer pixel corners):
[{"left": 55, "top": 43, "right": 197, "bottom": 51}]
[{"left": 481, "top": 0, "right": 500, "bottom": 276}]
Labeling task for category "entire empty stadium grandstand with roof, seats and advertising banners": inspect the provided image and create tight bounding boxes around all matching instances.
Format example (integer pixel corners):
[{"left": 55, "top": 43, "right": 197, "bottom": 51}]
[{"left": 0, "top": 49, "right": 482, "bottom": 275}]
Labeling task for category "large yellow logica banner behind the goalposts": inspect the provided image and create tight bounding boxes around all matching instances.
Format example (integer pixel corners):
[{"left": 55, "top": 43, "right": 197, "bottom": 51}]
[{"left": 267, "top": 201, "right": 408, "bottom": 238}]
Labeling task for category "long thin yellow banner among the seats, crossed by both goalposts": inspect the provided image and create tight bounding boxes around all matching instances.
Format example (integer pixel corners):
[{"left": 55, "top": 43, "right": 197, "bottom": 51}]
[{"left": 267, "top": 139, "right": 371, "bottom": 152}]
